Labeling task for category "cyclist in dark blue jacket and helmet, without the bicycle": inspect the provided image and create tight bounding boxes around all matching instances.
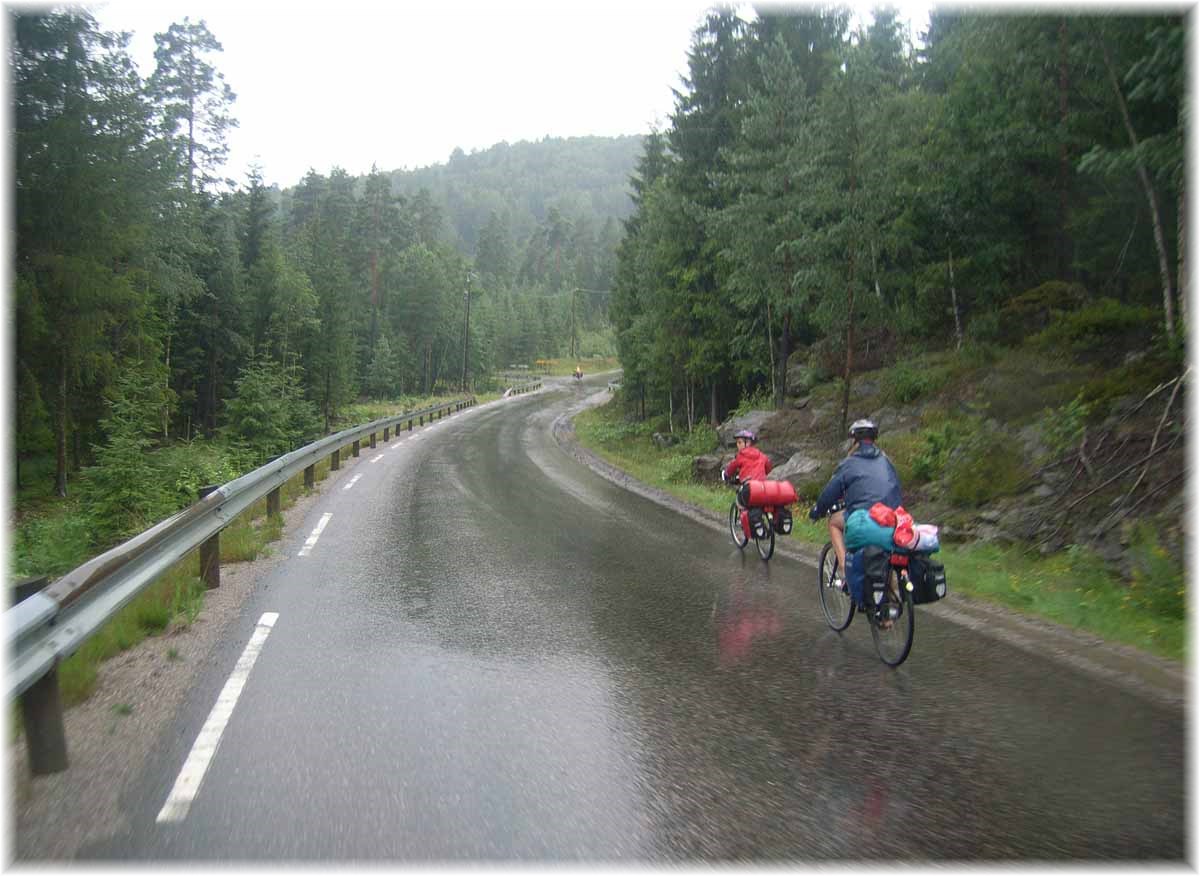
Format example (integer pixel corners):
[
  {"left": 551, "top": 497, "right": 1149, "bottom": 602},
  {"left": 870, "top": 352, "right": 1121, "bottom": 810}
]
[{"left": 809, "top": 420, "right": 904, "bottom": 577}]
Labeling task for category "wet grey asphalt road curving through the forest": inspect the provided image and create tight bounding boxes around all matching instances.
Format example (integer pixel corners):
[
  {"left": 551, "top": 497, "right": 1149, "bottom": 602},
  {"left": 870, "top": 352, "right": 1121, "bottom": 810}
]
[{"left": 82, "top": 386, "right": 1186, "bottom": 862}]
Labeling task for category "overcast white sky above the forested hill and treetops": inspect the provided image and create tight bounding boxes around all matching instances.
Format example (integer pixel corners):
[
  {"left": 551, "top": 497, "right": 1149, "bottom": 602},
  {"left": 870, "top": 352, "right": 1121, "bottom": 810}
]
[{"left": 79, "top": 0, "right": 925, "bottom": 186}]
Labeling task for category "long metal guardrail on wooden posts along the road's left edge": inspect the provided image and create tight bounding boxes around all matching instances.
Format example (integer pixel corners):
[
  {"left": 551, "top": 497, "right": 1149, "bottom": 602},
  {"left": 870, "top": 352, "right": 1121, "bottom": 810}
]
[{"left": 5, "top": 396, "right": 477, "bottom": 774}]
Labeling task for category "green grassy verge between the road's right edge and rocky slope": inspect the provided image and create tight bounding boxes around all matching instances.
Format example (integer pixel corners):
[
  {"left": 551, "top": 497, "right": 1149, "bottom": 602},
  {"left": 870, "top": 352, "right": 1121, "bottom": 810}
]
[{"left": 575, "top": 404, "right": 1187, "bottom": 660}]
